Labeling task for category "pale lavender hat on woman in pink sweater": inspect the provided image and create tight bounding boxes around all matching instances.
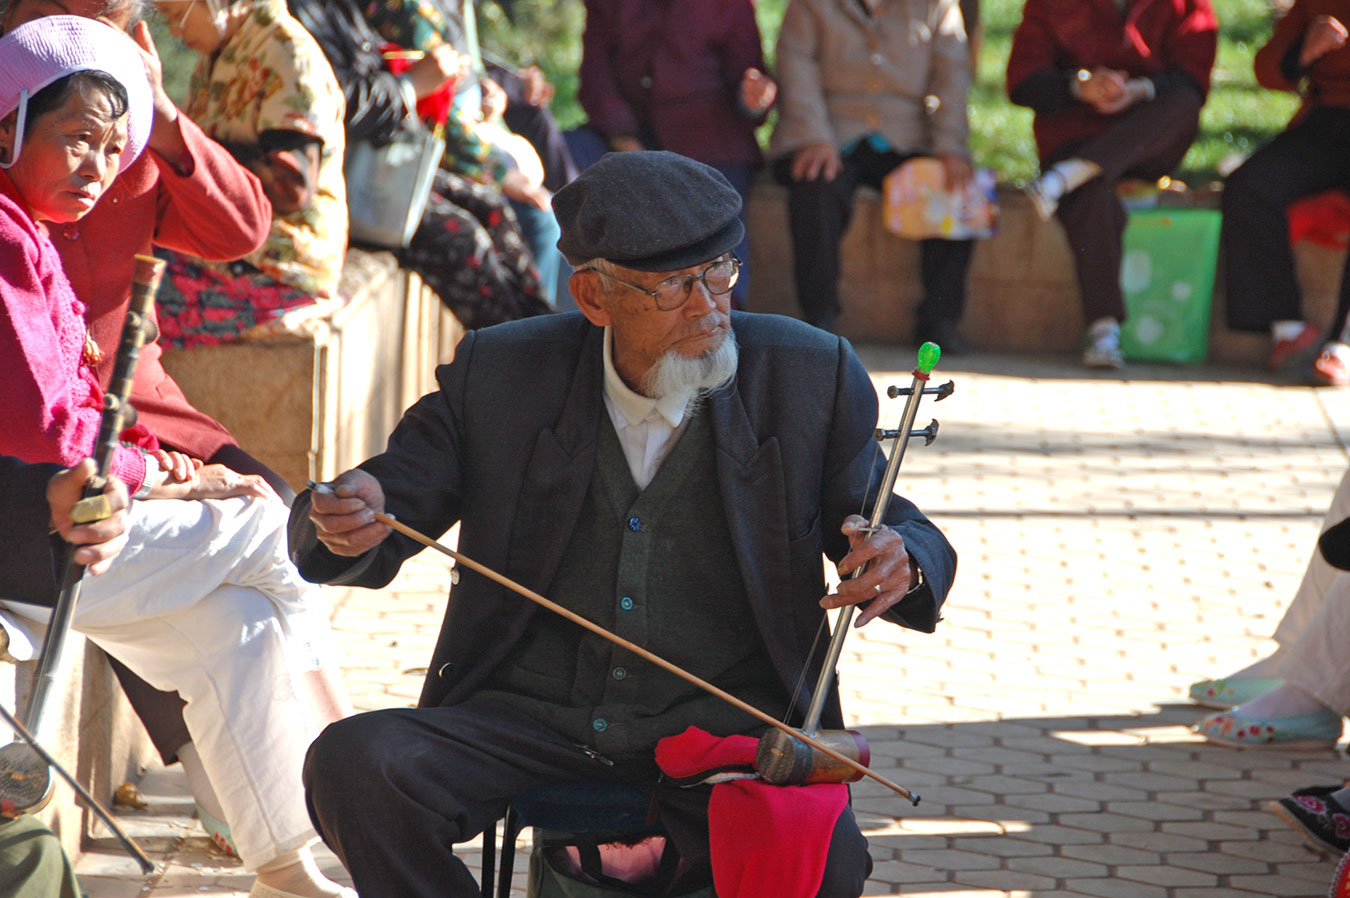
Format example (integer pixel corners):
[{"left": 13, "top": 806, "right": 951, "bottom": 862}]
[{"left": 0, "top": 16, "right": 154, "bottom": 169}]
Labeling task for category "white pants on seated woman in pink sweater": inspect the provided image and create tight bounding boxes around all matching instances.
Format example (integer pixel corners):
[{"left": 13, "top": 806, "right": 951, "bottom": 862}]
[{"left": 4, "top": 498, "right": 333, "bottom": 870}]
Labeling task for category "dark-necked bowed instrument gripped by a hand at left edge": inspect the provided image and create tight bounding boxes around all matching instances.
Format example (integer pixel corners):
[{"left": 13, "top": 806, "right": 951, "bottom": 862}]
[{"left": 0, "top": 255, "right": 165, "bottom": 866}]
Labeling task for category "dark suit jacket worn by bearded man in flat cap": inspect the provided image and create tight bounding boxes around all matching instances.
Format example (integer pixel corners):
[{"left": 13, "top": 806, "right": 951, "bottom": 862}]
[{"left": 290, "top": 313, "right": 956, "bottom": 727}]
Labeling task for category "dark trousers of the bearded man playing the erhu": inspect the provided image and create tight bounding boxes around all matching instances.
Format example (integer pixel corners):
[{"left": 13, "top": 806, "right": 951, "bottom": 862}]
[{"left": 304, "top": 698, "right": 872, "bottom": 898}]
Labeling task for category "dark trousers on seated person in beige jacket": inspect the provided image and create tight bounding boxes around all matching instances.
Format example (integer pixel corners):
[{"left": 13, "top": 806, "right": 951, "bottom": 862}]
[{"left": 774, "top": 140, "right": 975, "bottom": 331}]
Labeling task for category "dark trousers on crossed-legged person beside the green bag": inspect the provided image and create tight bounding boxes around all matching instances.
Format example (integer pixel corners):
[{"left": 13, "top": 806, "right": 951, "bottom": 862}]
[{"left": 1041, "top": 88, "right": 1202, "bottom": 323}]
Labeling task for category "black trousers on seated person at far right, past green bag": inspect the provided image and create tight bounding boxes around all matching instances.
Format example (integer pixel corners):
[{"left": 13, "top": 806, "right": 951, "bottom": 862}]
[{"left": 1220, "top": 108, "right": 1350, "bottom": 336}]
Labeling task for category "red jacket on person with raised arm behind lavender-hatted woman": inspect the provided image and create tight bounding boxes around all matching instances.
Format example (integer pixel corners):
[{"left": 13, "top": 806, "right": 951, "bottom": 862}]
[{"left": 51, "top": 115, "right": 271, "bottom": 459}]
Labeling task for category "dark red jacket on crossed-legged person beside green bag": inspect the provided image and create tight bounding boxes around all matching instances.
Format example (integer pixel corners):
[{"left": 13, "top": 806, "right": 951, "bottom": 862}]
[{"left": 1007, "top": 0, "right": 1218, "bottom": 159}]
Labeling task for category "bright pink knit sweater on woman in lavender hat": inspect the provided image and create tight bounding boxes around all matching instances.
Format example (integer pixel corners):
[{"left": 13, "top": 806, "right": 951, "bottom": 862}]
[{"left": 0, "top": 171, "right": 159, "bottom": 492}]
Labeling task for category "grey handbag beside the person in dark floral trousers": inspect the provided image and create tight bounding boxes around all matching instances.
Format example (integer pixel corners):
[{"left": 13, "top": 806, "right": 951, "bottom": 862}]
[{"left": 343, "top": 119, "right": 444, "bottom": 250}]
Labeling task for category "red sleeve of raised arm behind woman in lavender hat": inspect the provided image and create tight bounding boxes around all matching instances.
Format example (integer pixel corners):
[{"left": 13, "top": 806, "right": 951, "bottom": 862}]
[{"left": 147, "top": 115, "right": 271, "bottom": 262}]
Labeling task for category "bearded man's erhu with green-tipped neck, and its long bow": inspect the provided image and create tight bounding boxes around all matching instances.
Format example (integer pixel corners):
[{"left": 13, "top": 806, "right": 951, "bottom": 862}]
[{"left": 309, "top": 343, "right": 953, "bottom": 805}]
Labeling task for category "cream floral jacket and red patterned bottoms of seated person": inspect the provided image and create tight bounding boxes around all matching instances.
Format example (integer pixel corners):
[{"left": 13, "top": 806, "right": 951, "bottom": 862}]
[{"left": 155, "top": 0, "right": 347, "bottom": 348}]
